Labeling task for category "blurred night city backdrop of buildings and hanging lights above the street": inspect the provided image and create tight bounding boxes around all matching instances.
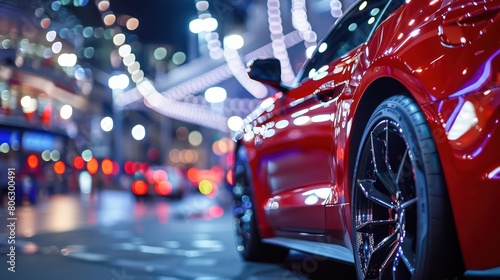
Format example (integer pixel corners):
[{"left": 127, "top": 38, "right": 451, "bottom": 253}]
[{"left": 0, "top": 0, "right": 352, "bottom": 201}]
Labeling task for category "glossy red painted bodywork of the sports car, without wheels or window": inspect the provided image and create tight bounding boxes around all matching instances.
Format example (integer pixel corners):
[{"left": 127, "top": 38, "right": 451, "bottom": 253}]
[{"left": 235, "top": 0, "right": 500, "bottom": 275}]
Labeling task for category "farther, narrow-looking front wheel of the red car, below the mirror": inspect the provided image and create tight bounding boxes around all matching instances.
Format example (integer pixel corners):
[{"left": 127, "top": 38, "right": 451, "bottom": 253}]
[{"left": 233, "top": 147, "right": 289, "bottom": 262}]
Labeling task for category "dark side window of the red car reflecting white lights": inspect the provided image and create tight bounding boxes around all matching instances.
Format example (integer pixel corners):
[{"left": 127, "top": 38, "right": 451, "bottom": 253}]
[{"left": 299, "top": 0, "right": 404, "bottom": 81}]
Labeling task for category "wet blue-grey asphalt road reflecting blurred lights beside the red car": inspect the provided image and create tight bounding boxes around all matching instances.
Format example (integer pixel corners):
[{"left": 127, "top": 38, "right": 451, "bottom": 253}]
[{"left": 0, "top": 190, "right": 355, "bottom": 280}]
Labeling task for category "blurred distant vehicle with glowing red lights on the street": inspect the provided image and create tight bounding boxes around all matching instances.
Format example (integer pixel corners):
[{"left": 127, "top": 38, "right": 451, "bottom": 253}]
[{"left": 131, "top": 165, "right": 187, "bottom": 199}]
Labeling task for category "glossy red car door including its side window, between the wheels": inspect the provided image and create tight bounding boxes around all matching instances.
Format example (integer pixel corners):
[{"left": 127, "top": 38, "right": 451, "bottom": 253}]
[{"left": 260, "top": 1, "right": 398, "bottom": 234}]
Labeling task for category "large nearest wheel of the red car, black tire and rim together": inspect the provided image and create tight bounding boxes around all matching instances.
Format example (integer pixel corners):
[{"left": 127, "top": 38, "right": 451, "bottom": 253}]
[{"left": 351, "top": 95, "right": 461, "bottom": 279}]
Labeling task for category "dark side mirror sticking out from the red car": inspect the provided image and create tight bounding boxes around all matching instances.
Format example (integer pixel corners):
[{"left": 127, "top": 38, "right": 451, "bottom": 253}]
[{"left": 247, "top": 58, "right": 286, "bottom": 90}]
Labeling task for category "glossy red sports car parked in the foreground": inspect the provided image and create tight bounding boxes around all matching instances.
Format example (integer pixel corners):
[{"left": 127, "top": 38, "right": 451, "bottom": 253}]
[{"left": 233, "top": 0, "right": 500, "bottom": 279}]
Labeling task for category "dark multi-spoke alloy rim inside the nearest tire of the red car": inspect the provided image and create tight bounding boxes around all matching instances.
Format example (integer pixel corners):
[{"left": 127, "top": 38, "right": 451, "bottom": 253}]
[{"left": 354, "top": 119, "right": 418, "bottom": 279}]
